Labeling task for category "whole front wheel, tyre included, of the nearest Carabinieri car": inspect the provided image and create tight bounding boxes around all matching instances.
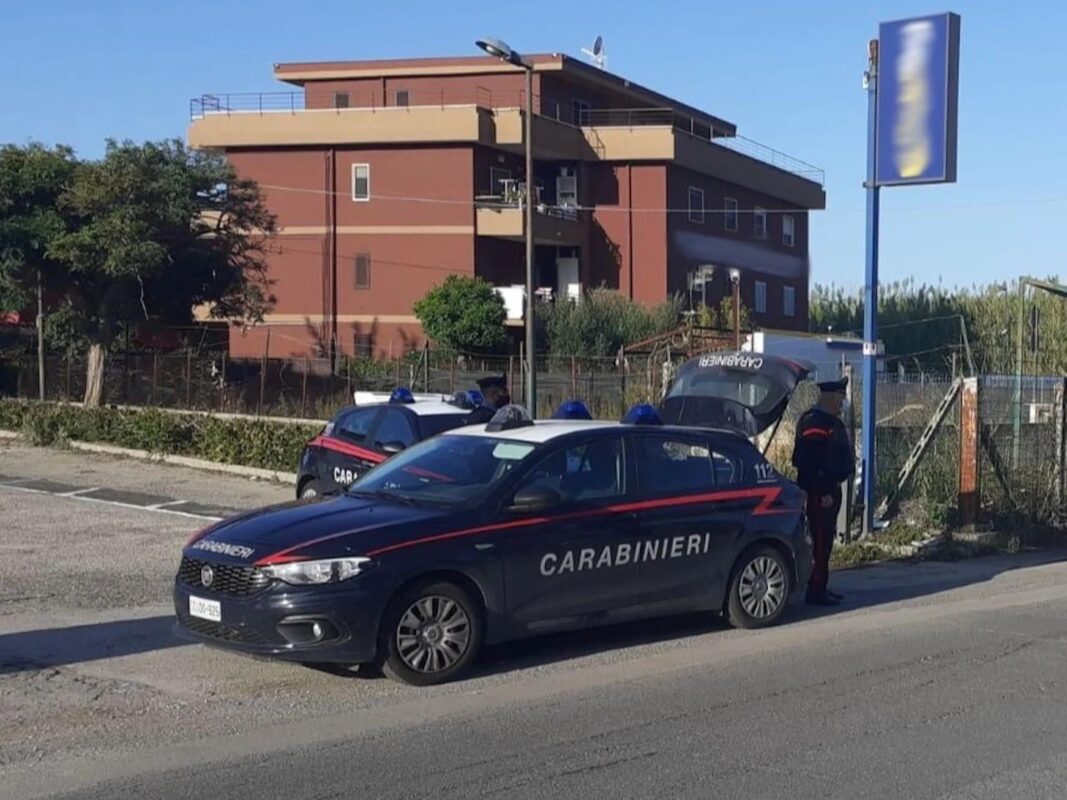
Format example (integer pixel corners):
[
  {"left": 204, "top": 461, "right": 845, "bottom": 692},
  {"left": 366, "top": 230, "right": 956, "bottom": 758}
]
[{"left": 381, "top": 582, "right": 482, "bottom": 686}]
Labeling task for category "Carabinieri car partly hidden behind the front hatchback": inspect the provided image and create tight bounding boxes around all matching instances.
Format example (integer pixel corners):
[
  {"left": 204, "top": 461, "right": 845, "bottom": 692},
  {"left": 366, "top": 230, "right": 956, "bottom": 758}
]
[{"left": 297, "top": 388, "right": 476, "bottom": 498}]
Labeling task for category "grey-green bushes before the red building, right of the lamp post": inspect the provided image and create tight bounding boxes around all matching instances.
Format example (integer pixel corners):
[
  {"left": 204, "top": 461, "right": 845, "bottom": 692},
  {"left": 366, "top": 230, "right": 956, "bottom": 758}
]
[{"left": 539, "top": 289, "right": 682, "bottom": 357}]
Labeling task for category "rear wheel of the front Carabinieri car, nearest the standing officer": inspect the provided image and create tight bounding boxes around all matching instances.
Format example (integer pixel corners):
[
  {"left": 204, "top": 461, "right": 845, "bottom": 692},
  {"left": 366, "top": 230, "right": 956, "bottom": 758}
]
[{"left": 727, "top": 546, "right": 792, "bottom": 628}]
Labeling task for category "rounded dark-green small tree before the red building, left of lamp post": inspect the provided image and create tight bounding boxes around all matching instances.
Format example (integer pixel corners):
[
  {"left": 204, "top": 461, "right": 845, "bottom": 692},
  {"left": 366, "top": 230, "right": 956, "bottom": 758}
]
[{"left": 415, "top": 275, "right": 508, "bottom": 353}]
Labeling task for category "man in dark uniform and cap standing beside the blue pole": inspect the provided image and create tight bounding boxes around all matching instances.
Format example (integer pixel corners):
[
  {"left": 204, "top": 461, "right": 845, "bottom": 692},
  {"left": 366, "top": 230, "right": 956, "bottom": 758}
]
[{"left": 793, "top": 378, "right": 856, "bottom": 606}]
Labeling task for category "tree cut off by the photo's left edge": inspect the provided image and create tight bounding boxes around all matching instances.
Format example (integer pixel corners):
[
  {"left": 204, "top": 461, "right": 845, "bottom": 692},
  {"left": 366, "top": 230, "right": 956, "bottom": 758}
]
[{"left": 0, "top": 143, "right": 77, "bottom": 399}]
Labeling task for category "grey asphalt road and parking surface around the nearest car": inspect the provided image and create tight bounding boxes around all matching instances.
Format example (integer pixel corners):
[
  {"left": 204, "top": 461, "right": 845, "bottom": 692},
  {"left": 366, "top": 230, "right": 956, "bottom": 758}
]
[{"left": 0, "top": 445, "right": 1067, "bottom": 800}]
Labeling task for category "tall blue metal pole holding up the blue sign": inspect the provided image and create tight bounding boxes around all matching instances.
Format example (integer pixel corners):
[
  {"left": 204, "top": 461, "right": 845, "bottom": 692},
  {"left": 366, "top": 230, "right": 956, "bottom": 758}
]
[{"left": 862, "top": 40, "right": 879, "bottom": 535}]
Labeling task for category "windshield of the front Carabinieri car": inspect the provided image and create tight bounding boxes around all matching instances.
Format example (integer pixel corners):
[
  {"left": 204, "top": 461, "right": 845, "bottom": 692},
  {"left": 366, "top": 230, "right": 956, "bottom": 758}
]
[{"left": 348, "top": 434, "right": 535, "bottom": 506}]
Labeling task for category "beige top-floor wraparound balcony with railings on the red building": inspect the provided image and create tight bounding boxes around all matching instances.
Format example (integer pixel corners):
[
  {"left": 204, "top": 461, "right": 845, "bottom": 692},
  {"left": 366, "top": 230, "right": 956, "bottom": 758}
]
[{"left": 189, "top": 87, "right": 826, "bottom": 206}]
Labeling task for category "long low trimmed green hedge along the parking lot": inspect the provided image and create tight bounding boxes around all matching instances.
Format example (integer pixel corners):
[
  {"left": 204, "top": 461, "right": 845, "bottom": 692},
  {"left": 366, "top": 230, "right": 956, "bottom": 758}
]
[{"left": 0, "top": 400, "right": 321, "bottom": 473}]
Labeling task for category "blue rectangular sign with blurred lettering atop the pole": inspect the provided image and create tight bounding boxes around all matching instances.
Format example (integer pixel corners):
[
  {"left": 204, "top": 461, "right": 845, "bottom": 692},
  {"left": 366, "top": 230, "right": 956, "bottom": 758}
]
[{"left": 875, "top": 14, "right": 959, "bottom": 186}]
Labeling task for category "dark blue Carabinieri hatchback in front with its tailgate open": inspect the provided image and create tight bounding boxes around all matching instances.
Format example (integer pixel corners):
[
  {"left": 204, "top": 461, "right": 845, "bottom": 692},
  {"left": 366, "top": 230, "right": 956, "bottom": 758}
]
[{"left": 174, "top": 354, "right": 811, "bottom": 686}]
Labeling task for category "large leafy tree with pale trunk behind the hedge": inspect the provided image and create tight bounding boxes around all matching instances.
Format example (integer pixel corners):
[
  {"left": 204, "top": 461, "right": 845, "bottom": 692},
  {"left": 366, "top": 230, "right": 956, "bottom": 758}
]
[{"left": 48, "top": 141, "right": 275, "bottom": 405}]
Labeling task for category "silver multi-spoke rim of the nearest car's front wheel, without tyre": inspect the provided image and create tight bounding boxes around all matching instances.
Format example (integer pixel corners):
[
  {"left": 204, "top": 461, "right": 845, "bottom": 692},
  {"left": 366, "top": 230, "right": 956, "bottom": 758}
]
[{"left": 396, "top": 595, "right": 471, "bottom": 674}]
